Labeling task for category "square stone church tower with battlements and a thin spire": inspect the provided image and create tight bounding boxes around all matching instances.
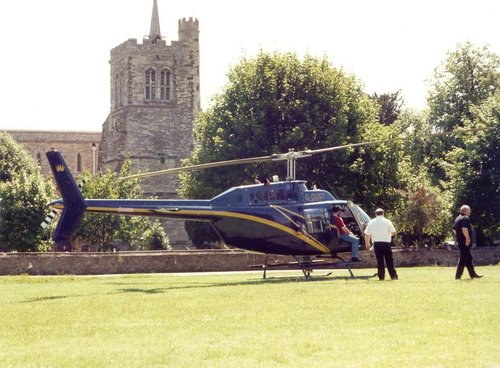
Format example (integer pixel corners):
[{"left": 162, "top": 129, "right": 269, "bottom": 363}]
[{"left": 99, "top": 0, "right": 200, "bottom": 242}]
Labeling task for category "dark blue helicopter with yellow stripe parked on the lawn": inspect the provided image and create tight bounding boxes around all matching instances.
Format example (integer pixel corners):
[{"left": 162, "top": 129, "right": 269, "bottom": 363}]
[{"left": 46, "top": 129, "right": 484, "bottom": 278}]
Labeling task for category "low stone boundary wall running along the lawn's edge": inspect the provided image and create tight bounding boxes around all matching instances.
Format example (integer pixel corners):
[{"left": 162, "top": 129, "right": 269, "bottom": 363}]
[{"left": 0, "top": 247, "right": 500, "bottom": 275}]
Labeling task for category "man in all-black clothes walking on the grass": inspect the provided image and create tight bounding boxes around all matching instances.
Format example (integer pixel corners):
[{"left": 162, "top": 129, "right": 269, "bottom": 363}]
[{"left": 452, "top": 205, "right": 483, "bottom": 280}]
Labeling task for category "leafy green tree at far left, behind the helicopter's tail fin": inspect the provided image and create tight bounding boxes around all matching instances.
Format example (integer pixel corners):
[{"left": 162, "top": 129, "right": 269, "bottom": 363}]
[{"left": 0, "top": 132, "right": 54, "bottom": 251}]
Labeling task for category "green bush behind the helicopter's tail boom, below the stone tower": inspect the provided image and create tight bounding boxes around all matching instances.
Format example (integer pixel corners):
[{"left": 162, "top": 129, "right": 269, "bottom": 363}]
[{"left": 75, "top": 159, "right": 149, "bottom": 250}]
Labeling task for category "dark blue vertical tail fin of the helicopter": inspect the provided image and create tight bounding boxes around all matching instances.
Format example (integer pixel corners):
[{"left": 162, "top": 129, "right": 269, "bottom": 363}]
[{"left": 46, "top": 150, "right": 87, "bottom": 251}]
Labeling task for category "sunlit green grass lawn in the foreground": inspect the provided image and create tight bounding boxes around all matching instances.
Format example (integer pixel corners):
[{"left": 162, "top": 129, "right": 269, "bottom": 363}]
[{"left": 0, "top": 266, "right": 500, "bottom": 368}]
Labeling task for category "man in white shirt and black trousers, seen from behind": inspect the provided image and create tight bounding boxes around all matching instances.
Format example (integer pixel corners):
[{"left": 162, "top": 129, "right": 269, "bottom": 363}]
[{"left": 365, "top": 208, "right": 398, "bottom": 280}]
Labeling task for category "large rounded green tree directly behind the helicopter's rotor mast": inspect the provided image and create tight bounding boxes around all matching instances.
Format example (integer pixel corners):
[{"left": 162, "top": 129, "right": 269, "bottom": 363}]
[{"left": 181, "top": 52, "right": 397, "bottom": 213}]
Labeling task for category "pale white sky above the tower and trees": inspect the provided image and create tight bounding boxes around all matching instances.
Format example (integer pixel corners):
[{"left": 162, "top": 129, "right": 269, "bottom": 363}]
[{"left": 0, "top": 0, "right": 500, "bottom": 131}]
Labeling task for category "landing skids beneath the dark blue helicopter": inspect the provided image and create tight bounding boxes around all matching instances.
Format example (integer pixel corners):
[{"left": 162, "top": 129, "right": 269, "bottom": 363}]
[{"left": 254, "top": 253, "right": 354, "bottom": 279}]
